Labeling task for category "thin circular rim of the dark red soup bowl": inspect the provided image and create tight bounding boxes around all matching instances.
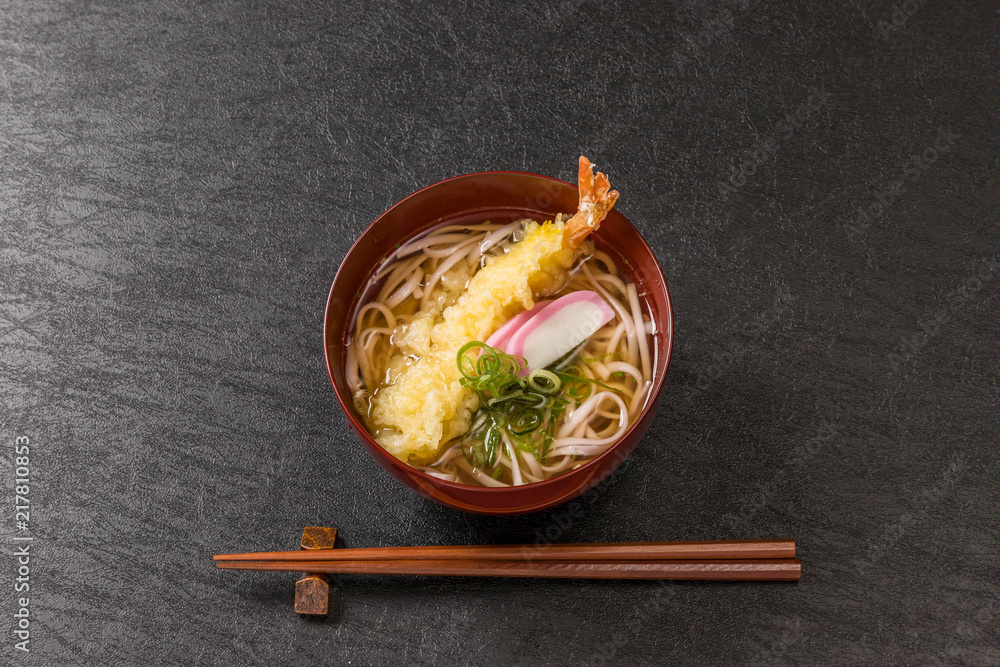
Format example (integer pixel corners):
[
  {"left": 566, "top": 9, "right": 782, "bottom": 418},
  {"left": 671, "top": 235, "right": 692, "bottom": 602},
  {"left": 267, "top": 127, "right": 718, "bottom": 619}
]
[{"left": 323, "top": 171, "right": 674, "bottom": 495}]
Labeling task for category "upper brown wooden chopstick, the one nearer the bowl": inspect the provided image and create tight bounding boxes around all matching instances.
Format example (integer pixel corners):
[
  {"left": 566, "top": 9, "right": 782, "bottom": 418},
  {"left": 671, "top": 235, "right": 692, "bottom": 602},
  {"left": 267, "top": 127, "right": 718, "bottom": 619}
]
[{"left": 213, "top": 540, "right": 795, "bottom": 572}]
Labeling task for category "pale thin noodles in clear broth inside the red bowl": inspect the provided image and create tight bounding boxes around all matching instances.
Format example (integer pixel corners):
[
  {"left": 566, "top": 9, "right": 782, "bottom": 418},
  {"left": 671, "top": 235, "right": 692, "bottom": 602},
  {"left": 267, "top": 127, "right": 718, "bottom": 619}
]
[{"left": 346, "top": 216, "right": 655, "bottom": 487}]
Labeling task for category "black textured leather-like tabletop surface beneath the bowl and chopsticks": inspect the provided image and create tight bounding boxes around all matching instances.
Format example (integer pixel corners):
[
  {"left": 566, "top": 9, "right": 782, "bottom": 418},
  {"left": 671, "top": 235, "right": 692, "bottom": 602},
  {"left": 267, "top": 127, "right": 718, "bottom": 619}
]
[{"left": 0, "top": 0, "right": 1000, "bottom": 665}]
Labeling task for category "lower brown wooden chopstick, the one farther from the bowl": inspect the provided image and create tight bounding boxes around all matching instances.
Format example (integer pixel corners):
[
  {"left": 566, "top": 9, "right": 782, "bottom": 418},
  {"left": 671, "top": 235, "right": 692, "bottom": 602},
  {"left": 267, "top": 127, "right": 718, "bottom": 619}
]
[{"left": 216, "top": 558, "right": 802, "bottom": 581}]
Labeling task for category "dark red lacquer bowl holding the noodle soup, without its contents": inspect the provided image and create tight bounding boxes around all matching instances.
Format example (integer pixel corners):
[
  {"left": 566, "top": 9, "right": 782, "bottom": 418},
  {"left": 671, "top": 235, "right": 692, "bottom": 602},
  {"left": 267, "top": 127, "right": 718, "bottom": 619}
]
[{"left": 323, "top": 171, "right": 673, "bottom": 514}]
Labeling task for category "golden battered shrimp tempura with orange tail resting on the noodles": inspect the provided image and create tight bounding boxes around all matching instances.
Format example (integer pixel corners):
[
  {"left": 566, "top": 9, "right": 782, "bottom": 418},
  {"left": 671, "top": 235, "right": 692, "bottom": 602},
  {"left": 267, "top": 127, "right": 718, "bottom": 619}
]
[{"left": 370, "top": 155, "right": 618, "bottom": 463}]
